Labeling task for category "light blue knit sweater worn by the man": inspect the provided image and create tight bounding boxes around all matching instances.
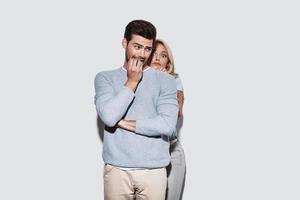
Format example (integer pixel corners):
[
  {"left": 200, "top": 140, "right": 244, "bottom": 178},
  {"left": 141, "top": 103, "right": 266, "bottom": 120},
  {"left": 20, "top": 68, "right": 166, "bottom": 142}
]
[{"left": 95, "top": 67, "right": 178, "bottom": 168}]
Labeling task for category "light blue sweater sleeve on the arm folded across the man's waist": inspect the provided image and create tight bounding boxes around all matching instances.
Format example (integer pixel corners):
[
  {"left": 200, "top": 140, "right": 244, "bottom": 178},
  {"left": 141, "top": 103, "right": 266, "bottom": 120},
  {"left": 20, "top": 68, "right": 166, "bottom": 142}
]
[{"left": 135, "top": 77, "right": 178, "bottom": 136}]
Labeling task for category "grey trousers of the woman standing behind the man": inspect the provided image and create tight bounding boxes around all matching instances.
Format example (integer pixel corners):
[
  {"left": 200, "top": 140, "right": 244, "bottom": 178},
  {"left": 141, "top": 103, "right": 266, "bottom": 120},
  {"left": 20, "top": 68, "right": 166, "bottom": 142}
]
[{"left": 166, "top": 140, "right": 186, "bottom": 200}]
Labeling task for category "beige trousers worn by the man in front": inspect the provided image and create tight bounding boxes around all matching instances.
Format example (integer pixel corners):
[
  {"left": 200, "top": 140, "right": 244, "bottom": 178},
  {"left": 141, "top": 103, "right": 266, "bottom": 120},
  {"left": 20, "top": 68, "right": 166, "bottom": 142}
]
[{"left": 103, "top": 164, "right": 167, "bottom": 200}]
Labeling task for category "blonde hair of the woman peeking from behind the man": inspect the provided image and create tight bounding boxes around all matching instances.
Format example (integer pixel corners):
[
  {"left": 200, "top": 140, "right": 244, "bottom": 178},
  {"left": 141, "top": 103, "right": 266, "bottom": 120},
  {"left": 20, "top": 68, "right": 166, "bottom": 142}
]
[{"left": 149, "top": 39, "right": 178, "bottom": 78}]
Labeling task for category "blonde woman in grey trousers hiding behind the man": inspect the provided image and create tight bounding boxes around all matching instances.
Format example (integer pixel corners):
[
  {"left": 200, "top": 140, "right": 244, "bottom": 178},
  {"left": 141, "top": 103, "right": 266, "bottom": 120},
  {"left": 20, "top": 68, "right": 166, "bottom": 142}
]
[{"left": 150, "top": 39, "right": 186, "bottom": 200}]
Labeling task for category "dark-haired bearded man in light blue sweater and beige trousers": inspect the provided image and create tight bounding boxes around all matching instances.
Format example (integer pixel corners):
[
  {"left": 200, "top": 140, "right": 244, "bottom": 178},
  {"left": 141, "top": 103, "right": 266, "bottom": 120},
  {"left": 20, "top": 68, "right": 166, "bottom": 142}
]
[{"left": 95, "top": 20, "right": 178, "bottom": 200}]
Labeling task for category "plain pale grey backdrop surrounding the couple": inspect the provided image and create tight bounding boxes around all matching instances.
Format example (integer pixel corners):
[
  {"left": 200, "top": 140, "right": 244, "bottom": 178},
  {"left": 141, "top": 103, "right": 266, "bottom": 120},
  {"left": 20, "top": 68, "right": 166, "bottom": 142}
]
[{"left": 0, "top": 0, "right": 300, "bottom": 200}]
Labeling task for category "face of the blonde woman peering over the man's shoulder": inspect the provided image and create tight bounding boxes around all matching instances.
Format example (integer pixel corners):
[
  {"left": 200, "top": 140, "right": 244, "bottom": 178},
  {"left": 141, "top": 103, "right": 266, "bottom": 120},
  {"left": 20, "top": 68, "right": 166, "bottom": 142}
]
[{"left": 151, "top": 44, "right": 169, "bottom": 70}]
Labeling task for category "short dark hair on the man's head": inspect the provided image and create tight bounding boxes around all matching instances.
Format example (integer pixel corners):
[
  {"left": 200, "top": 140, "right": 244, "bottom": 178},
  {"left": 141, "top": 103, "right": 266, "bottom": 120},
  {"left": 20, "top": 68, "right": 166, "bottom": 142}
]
[{"left": 124, "top": 20, "right": 156, "bottom": 42}]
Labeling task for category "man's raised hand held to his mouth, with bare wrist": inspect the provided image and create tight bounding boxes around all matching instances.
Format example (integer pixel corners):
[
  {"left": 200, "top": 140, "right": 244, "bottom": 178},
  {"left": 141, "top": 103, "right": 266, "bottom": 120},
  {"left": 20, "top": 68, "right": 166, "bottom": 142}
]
[{"left": 125, "top": 57, "right": 144, "bottom": 91}]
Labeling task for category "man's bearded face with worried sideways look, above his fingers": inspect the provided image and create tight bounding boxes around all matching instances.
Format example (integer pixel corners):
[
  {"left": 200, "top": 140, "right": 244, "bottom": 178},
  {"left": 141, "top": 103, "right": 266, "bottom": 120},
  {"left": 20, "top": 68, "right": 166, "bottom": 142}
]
[{"left": 122, "top": 34, "right": 153, "bottom": 66}]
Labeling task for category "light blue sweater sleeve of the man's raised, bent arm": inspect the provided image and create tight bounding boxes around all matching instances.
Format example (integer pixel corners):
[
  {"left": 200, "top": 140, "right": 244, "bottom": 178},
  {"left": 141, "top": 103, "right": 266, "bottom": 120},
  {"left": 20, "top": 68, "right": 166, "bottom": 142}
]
[{"left": 95, "top": 73, "right": 134, "bottom": 127}]
